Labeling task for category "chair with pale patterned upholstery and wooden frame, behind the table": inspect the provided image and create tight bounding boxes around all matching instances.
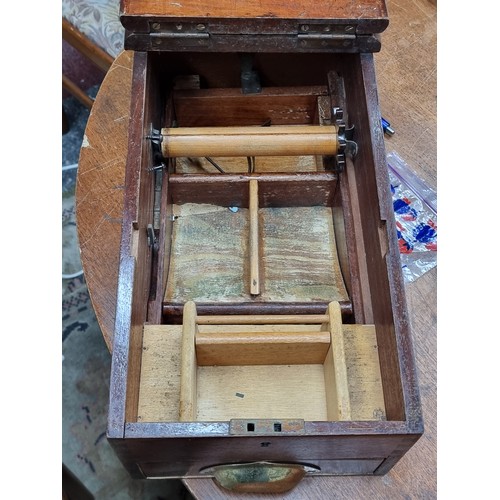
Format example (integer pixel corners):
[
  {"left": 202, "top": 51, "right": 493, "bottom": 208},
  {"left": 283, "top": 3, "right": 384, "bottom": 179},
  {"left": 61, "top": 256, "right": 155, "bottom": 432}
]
[{"left": 62, "top": 0, "right": 124, "bottom": 109}]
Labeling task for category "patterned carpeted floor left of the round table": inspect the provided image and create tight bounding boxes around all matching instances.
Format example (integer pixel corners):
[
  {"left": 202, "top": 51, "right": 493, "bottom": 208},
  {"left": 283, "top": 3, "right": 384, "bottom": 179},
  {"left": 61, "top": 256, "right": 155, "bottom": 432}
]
[{"left": 62, "top": 47, "right": 192, "bottom": 500}]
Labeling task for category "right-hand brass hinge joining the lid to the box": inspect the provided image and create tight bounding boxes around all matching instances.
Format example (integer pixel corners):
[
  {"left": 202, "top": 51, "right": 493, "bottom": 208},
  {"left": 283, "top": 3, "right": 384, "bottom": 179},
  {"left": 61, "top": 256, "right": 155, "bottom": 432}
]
[{"left": 297, "top": 24, "right": 356, "bottom": 49}]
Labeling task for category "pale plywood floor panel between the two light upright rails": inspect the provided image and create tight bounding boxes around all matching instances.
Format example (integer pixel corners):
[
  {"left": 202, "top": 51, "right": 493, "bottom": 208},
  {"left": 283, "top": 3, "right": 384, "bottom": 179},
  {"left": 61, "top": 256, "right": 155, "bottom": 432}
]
[{"left": 197, "top": 365, "right": 326, "bottom": 421}]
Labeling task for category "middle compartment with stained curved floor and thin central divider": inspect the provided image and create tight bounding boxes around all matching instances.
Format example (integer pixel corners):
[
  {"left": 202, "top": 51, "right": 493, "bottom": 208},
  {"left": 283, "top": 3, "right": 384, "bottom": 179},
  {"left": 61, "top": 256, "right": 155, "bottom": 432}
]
[{"left": 164, "top": 180, "right": 348, "bottom": 303}]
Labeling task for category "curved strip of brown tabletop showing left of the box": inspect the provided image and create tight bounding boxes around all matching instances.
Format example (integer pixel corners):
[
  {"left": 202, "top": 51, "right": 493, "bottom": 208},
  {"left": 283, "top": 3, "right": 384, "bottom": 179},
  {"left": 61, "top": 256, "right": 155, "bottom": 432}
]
[{"left": 76, "top": 51, "right": 133, "bottom": 350}]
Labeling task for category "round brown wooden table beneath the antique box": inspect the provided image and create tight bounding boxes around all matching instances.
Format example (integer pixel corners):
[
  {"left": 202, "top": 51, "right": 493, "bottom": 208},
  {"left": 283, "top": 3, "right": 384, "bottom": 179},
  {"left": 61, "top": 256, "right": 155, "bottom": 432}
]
[{"left": 76, "top": 1, "right": 437, "bottom": 499}]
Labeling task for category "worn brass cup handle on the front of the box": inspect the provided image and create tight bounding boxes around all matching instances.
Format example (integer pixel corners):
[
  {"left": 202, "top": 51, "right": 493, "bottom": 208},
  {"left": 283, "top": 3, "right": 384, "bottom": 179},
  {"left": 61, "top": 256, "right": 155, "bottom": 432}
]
[{"left": 200, "top": 462, "right": 319, "bottom": 493}]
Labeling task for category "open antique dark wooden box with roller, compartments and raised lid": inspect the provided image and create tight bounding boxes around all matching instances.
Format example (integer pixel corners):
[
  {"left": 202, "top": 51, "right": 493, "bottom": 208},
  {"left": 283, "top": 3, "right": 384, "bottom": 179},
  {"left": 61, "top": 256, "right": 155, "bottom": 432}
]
[{"left": 108, "top": 0, "right": 423, "bottom": 491}]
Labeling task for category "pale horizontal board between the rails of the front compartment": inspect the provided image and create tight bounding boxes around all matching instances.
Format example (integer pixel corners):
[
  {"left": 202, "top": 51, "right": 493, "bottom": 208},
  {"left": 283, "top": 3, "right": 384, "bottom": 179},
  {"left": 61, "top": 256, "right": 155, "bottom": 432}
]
[{"left": 196, "top": 330, "right": 330, "bottom": 366}]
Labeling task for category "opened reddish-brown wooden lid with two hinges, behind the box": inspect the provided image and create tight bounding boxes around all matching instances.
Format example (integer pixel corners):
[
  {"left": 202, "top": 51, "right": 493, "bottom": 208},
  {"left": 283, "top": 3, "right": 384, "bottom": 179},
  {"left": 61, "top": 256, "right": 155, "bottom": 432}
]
[{"left": 121, "top": 0, "right": 389, "bottom": 52}]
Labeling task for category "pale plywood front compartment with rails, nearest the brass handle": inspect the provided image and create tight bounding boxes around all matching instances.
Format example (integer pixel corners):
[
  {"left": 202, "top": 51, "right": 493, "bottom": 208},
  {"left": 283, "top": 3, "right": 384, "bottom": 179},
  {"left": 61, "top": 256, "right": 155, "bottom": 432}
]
[{"left": 137, "top": 302, "right": 385, "bottom": 424}]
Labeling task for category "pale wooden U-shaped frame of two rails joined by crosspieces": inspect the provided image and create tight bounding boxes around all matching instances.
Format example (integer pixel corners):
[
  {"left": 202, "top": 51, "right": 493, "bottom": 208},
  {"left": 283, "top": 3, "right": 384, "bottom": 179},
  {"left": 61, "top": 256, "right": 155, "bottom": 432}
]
[{"left": 179, "top": 301, "right": 354, "bottom": 421}]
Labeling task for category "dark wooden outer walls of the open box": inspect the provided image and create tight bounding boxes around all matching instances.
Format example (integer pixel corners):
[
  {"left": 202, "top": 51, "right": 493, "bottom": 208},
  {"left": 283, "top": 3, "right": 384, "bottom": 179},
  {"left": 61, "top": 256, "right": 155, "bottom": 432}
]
[{"left": 108, "top": 52, "right": 423, "bottom": 478}]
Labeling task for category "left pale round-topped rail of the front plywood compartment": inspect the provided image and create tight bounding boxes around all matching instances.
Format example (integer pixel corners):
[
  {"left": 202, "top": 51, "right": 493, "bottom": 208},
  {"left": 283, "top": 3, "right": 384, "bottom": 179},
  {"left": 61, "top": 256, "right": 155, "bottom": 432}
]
[{"left": 179, "top": 301, "right": 197, "bottom": 422}]
